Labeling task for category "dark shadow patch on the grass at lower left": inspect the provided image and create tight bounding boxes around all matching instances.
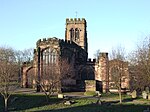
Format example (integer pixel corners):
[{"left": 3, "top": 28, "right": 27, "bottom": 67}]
[{"left": 0, "top": 94, "right": 61, "bottom": 112}]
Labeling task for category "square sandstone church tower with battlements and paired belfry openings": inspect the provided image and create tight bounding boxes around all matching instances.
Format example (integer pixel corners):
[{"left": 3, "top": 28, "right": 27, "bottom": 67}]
[{"left": 65, "top": 18, "right": 88, "bottom": 52}]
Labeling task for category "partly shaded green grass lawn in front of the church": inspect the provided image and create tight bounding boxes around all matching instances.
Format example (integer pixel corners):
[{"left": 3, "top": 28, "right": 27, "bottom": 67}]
[{"left": 0, "top": 94, "right": 150, "bottom": 112}]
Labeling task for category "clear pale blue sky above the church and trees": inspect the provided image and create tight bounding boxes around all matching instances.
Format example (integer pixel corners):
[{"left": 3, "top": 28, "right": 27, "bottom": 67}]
[{"left": 0, "top": 0, "right": 150, "bottom": 58}]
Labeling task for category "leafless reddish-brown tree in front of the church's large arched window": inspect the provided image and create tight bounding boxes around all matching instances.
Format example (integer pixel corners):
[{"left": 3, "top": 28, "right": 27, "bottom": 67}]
[{"left": 37, "top": 59, "right": 73, "bottom": 101}]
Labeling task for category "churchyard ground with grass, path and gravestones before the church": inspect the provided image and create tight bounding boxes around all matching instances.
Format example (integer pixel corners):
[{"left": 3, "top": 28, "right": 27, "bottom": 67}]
[{"left": 0, "top": 89, "right": 150, "bottom": 112}]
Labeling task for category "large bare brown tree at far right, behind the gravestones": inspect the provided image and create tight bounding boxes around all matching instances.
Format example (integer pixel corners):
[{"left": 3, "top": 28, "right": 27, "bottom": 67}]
[{"left": 130, "top": 37, "right": 150, "bottom": 91}]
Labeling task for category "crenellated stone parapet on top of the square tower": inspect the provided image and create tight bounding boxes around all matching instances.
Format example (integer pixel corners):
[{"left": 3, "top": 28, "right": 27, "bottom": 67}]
[{"left": 66, "top": 18, "right": 86, "bottom": 24}]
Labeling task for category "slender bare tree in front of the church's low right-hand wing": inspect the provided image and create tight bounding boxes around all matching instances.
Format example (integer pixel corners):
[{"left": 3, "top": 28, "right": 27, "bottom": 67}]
[{"left": 110, "top": 46, "right": 125, "bottom": 103}]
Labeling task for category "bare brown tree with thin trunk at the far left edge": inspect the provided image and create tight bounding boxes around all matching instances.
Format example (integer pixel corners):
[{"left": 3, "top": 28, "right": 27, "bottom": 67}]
[{"left": 0, "top": 47, "right": 18, "bottom": 112}]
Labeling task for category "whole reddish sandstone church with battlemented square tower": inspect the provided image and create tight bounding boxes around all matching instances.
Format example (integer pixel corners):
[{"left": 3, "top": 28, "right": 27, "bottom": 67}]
[{"left": 22, "top": 18, "right": 129, "bottom": 92}]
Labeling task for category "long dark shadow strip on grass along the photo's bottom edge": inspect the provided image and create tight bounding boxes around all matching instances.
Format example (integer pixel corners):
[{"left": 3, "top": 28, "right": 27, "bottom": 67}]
[{"left": 37, "top": 104, "right": 150, "bottom": 112}]
